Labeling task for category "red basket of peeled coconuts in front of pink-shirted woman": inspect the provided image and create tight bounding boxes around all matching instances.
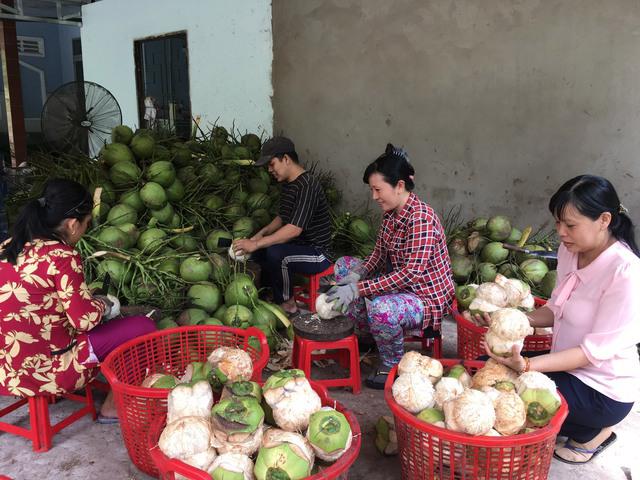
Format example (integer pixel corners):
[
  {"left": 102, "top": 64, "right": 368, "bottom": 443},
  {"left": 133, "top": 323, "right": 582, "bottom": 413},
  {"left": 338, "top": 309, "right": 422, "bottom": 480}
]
[{"left": 384, "top": 359, "right": 569, "bottom": 480}]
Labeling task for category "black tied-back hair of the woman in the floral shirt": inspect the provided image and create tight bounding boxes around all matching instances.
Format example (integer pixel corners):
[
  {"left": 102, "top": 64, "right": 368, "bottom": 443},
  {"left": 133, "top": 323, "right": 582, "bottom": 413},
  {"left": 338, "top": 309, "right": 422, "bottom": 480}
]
[{"left": 0, "top": 179, "right": 93, "bottom": 265}]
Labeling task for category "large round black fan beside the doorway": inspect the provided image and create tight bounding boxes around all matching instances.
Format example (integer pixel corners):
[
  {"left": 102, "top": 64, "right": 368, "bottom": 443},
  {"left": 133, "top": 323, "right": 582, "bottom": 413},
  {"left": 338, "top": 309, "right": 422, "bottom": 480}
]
[{"left": 40, "top": 82, "right": 122, "bottom": 157}]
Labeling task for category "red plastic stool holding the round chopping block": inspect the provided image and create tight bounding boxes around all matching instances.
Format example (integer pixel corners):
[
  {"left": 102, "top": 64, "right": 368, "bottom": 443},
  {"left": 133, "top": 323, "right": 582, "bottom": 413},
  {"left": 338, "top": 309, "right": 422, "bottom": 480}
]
[{"left": 292, "top": 335, "right": 362, "bottom": 394}]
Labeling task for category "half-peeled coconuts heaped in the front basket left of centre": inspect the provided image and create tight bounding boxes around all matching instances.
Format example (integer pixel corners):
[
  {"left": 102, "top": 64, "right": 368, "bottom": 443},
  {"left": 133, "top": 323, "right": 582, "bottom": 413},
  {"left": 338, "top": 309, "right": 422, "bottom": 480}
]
[{"left": 142, "top": 347, "right": 353, "bottom": 480}]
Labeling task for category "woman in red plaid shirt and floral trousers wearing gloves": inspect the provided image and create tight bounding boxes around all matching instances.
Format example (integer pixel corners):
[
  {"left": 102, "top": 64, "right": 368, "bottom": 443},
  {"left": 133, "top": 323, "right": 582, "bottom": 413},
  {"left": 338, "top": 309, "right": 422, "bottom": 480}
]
[{"left": 329, "top": 144, "right": 454, "bottom": 389}]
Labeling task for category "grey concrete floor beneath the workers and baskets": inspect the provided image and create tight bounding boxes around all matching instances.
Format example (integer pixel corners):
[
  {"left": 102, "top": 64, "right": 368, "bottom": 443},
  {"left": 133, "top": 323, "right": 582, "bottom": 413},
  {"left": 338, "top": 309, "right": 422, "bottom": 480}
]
[{"left": 0, "top": 321, "right": 640, "bottom": 480}]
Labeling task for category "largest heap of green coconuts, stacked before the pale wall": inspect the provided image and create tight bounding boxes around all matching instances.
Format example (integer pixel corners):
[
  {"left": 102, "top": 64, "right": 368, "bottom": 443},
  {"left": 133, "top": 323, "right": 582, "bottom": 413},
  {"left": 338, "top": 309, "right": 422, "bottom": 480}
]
[{"left": 78, "top": 126, "right": 289, "bottom": 348}]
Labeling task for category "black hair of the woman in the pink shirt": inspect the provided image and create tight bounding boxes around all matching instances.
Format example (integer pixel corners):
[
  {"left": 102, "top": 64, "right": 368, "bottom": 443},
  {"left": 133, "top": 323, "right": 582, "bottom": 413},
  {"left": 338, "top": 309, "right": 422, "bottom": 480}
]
[{"left": 549, "top": 175, "right": 640, "bottom": 257}]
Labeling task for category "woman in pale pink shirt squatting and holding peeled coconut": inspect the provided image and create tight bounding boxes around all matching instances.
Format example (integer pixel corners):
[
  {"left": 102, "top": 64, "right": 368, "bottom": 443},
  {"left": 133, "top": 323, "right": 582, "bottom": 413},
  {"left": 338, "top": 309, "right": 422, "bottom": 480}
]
[{"left": 487, "top": 175, "right": 640, "bottom": 464}]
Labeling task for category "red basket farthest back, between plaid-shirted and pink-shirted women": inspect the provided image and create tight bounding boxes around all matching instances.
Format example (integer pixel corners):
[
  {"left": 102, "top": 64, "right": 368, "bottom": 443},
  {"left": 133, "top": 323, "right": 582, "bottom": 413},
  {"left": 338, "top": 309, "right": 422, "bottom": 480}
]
[{"left": 451, "top": 297, "right": 553, "bottom": 360}]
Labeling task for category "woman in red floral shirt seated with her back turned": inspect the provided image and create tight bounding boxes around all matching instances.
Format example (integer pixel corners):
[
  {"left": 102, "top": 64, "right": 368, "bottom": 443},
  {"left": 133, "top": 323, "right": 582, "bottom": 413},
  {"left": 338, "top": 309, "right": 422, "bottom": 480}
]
[{"left": 0, "top": 180, "right": 155, "bottom": 418}]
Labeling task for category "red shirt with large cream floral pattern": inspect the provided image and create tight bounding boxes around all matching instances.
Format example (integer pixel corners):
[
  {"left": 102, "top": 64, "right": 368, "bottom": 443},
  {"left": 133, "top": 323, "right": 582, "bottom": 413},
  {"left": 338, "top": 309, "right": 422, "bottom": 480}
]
[{"left": 0, "top": 240, "right": 104, "bottom": 396}]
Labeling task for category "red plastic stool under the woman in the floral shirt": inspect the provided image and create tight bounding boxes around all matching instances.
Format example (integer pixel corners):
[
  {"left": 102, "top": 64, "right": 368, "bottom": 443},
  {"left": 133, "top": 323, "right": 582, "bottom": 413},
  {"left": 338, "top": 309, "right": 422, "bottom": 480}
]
[{"left": 0, "top": 384, "right": 97, "bottom": 452}]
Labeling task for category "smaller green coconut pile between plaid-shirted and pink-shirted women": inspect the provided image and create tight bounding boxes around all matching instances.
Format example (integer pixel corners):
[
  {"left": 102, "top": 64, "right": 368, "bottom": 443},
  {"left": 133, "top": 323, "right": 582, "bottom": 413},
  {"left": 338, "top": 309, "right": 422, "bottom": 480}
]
[{"left": 448, "top": 215, "right": 557, "bottom": 310}]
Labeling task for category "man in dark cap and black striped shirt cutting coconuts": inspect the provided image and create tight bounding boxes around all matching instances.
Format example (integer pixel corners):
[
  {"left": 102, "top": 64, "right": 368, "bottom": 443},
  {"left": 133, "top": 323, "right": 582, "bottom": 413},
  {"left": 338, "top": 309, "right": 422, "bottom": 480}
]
[{"left": 233, "top": 137, "right": 331, "bottom": 313}]
